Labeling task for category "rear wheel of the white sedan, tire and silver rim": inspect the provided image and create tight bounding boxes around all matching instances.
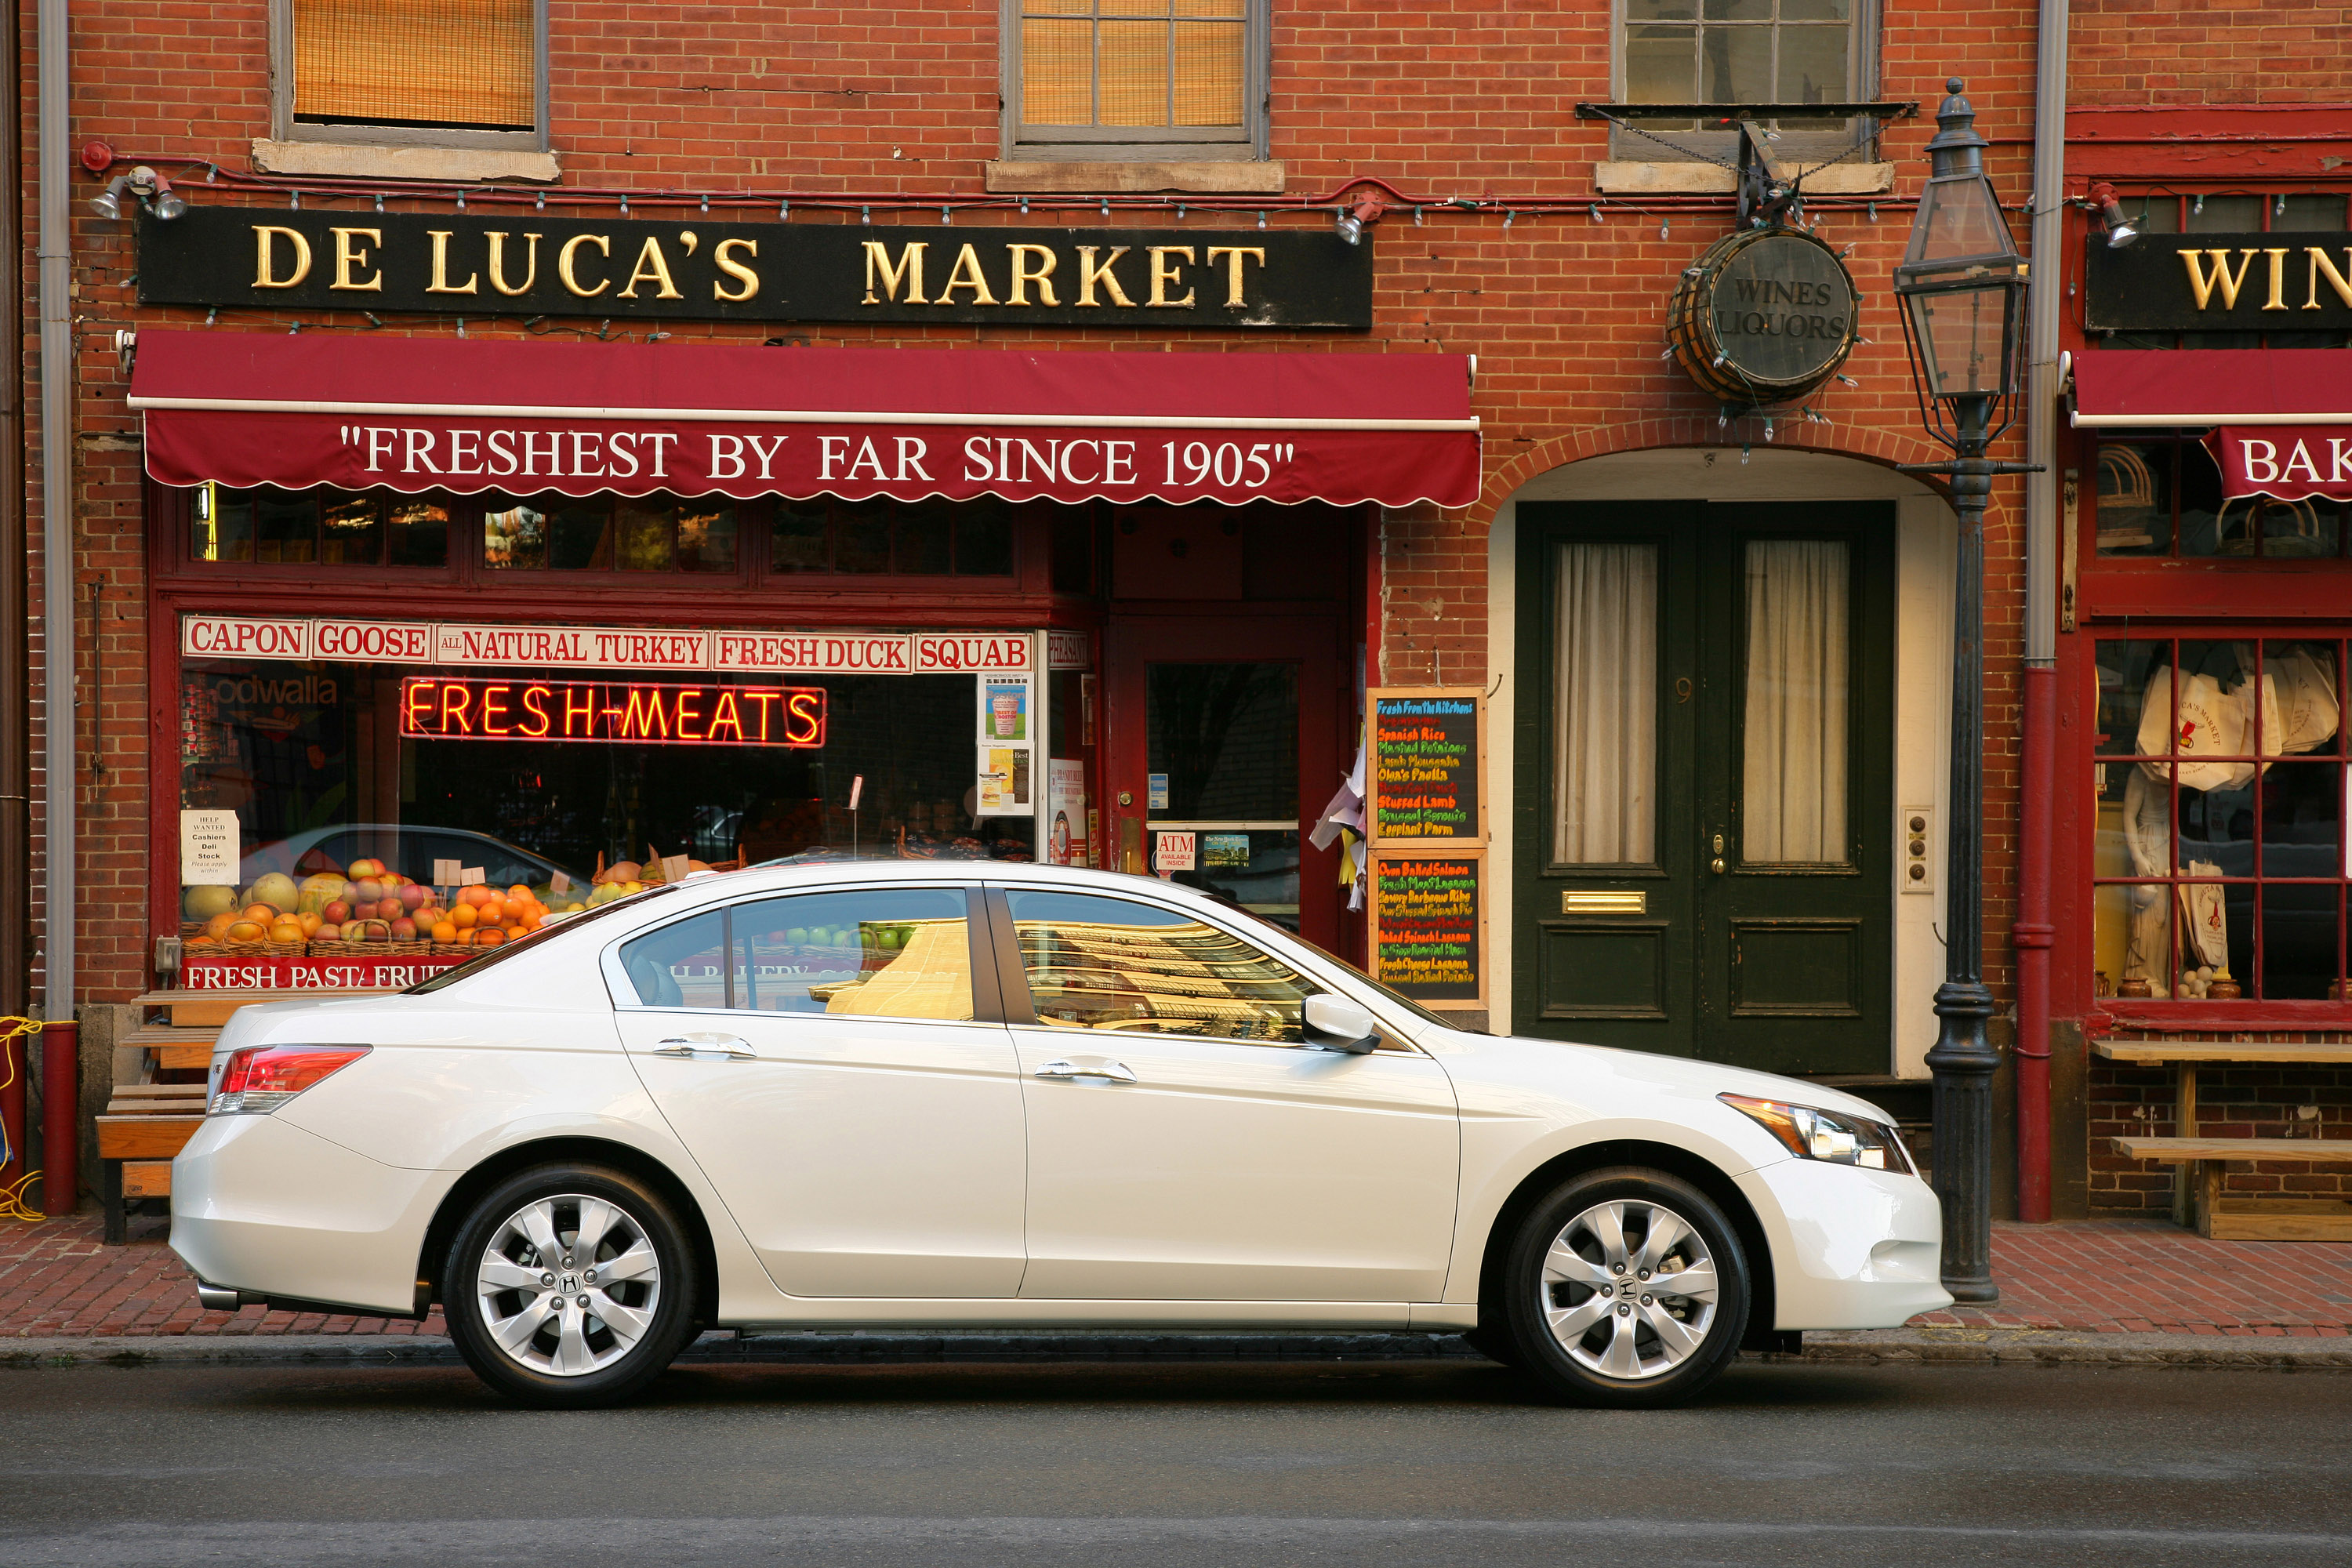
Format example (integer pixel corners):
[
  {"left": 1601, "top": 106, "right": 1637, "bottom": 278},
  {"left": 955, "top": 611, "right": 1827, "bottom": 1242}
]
[{"left": 442, "top": 1163, "right": 701, "bottom": 1410}]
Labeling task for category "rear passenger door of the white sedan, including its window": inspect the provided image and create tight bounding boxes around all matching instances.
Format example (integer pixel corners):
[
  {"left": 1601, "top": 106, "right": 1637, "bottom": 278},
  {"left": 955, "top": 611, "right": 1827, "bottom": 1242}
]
[{"left": 607, "top": 886, "right": 1023, "bottom": 1298}]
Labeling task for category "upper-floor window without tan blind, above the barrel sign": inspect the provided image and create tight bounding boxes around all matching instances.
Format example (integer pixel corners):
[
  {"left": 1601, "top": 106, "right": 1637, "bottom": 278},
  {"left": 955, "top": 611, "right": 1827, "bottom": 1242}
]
[{"left": 1613, "top": 0, "right": 1877, "bottom": 162}]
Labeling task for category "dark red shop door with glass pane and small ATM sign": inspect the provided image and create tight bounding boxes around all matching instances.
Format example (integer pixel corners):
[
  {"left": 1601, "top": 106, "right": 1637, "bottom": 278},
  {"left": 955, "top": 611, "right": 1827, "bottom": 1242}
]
[{"left": 1103, "top": 616, "right": 1348, "bottom": 947}]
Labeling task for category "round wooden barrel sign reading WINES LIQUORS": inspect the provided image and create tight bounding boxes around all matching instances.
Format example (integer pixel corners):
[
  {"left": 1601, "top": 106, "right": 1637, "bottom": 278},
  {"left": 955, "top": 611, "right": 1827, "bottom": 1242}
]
[{"left": 1665, "top": 228, "right": 1863, "bottom": 409}]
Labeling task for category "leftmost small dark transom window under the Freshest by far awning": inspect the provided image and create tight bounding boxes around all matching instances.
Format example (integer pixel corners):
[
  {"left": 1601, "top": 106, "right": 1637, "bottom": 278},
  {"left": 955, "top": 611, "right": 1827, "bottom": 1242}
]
[{"left": 188, "top": 485, "right": 449, "bottom": 567}]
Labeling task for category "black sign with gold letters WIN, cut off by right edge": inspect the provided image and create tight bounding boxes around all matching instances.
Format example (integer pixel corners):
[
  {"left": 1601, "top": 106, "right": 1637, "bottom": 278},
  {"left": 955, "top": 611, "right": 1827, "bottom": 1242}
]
[{"left": 2084, "top": 228, "right": 2352, "bottom": 332}]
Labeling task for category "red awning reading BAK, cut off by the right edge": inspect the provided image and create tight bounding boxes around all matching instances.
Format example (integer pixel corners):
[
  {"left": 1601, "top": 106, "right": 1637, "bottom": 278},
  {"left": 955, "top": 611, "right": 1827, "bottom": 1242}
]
[{"left": 2074, "top": 348, "right": 2352, "bottom": 501}]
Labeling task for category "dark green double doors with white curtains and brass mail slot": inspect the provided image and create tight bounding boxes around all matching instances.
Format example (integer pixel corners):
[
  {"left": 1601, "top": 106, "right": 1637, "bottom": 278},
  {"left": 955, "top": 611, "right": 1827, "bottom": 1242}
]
[{"left": 1512, "top": 501, "right": 1896, "bottom": 1074}]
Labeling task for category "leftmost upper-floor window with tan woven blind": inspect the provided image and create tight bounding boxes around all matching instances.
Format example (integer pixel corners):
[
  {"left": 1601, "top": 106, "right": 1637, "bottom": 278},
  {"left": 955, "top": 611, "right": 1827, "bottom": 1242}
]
[{"left": 270, "top": 0, "right": 548, "bottom": 148}]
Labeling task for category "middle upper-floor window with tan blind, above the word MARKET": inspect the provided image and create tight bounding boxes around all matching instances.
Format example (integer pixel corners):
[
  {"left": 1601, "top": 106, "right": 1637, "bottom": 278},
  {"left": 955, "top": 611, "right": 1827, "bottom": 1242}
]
[{"left": 1002, "top": 0, "right": 1268, "bottom": 162}]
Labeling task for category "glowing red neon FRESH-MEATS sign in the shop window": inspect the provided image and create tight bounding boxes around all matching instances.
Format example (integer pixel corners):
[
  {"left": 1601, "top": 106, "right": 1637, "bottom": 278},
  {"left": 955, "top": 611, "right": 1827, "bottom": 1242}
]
[{"left": 400, "top": 675, "right": 826, "bottom": 750}]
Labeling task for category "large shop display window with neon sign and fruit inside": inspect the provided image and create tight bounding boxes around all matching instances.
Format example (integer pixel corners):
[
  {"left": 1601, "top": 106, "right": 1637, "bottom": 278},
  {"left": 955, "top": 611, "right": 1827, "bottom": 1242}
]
[{"left": 179, "top": 659, "right": 1035, "bottom": 940}]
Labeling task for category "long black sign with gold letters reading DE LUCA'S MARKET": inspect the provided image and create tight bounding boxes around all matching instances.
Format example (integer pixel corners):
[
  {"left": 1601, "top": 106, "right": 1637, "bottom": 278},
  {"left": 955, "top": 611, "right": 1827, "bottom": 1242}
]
[{"left": 139, "top": 207, "right": 1371, "bottom": 332}]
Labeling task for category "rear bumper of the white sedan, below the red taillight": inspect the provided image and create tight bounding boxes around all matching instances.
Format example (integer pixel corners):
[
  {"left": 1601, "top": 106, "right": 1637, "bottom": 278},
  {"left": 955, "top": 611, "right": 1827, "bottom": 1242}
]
[{"left": 172, "top": 1116, "right": 459, "bottom": 1316}]
